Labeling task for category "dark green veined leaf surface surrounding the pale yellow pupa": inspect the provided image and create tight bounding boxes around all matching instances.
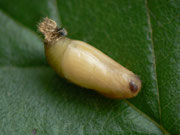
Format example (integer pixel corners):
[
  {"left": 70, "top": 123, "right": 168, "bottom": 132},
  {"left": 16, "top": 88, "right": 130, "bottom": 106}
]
[{"left": 0, "top": 0, "right": 180, "bottom": 135}]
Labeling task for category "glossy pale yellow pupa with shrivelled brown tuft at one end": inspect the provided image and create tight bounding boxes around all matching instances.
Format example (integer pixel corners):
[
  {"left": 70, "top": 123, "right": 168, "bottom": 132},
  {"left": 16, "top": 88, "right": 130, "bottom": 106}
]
[{"left": 38, "top": 17, "right": 141, "bottom": 99}]
